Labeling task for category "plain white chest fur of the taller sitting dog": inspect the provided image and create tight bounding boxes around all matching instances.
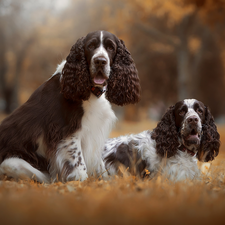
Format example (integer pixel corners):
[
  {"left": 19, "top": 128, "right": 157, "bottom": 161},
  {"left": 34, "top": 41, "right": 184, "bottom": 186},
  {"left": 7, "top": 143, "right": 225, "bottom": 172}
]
[{"left": 78, "top": 94, "right": 116, "bottom": 175}]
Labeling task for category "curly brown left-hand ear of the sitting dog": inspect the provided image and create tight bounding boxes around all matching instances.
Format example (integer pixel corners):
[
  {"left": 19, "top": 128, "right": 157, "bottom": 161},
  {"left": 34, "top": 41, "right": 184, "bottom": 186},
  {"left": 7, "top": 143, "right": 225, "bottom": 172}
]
[{"left": 61, "top": 37, "right": 91, "bottom": 101}]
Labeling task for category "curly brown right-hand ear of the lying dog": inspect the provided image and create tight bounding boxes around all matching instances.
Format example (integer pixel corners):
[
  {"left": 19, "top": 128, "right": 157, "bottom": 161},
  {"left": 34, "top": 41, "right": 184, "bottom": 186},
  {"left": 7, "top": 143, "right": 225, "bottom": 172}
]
[{"left": 197, "top": 106, "right": 220, "bottom": 162}]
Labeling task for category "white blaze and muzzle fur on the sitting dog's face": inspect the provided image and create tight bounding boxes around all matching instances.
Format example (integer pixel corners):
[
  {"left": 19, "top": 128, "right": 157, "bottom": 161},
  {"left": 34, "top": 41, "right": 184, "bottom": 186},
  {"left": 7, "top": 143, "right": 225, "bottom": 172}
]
[{"left": 90, "top": 31, "right": 110, "bottom": 84}]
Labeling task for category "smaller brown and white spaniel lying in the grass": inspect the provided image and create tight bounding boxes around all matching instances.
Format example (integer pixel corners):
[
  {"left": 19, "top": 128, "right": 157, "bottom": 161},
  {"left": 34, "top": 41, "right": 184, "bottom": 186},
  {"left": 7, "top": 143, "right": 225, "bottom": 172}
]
[{"left": 103, "top": 99, "right": 220, "bottom": 181}]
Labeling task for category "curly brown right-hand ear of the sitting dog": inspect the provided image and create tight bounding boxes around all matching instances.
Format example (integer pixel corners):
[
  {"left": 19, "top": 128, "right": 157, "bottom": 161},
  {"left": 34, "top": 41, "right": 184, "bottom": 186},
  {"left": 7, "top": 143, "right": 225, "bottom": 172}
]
[{"left": 106, "top": 40, "right": 141, "bottom": 106}]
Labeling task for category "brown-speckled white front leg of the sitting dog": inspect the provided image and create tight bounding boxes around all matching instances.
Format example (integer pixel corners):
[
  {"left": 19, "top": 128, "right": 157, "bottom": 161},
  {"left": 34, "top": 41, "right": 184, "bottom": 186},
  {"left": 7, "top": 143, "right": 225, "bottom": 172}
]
[{"left": 50, "top": 136, "right": 88, "bottom": 182}]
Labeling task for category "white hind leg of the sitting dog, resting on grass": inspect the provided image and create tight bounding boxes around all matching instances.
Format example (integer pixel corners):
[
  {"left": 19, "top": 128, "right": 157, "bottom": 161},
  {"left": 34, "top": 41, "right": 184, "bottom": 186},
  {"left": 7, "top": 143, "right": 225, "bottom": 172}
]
[{"left": 0, "top": 158, "right": 50, "bottom": 183}]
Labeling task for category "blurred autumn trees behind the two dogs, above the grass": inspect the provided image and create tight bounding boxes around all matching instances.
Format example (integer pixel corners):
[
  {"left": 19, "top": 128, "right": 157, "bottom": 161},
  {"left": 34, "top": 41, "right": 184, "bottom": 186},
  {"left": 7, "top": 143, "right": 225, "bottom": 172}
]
[{"left": 0, "top": 0, "right": 225, "bottom": 123}]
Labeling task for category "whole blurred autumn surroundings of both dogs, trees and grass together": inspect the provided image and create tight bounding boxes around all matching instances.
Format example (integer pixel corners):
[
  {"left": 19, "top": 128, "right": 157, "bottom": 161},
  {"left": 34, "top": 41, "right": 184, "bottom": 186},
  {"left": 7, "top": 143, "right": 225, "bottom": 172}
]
[{"left": 0, "top": 0, "right": 225, "bottom": 225}]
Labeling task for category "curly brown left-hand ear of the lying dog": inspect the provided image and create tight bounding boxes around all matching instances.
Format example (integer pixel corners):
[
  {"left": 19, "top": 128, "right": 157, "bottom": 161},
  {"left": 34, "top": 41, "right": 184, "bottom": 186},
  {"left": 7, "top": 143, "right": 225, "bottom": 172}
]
[{"left": 151, "top": 106, "right": 179, "bottom": 158}]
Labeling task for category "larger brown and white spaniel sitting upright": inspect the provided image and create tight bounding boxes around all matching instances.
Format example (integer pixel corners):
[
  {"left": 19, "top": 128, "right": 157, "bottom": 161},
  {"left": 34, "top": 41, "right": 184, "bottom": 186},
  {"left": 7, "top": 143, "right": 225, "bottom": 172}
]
[{"left": 0, "top": 31, "right": 140, "bottom": 182}]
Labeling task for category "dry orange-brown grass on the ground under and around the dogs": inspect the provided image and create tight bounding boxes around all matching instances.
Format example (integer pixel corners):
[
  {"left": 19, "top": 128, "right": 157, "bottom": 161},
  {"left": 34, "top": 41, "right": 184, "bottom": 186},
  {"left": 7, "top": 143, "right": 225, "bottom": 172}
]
[{"left": 0, "top": 118, "right": 225, "bottom": 225}]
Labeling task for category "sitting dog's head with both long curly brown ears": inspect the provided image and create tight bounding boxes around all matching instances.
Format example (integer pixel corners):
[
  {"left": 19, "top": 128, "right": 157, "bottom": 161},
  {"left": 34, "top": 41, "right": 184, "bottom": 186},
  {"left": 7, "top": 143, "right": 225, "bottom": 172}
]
[{"left": 61, "top": 31, "right": 140, "bottom": 105}]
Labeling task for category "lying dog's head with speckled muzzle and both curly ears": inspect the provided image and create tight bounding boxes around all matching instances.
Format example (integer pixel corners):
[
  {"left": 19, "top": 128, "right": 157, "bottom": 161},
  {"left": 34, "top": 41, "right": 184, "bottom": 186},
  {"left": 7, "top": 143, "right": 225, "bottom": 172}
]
[{"left": 152, "top": 99, "right": 220, "bottom": 162}]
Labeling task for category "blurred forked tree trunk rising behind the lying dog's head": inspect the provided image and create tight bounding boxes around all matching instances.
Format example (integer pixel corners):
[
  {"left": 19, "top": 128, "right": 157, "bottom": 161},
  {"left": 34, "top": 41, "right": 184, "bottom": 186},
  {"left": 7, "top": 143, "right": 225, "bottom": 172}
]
[{"left": 137, "top": 10, "right": 202, "bottom": 100}]
